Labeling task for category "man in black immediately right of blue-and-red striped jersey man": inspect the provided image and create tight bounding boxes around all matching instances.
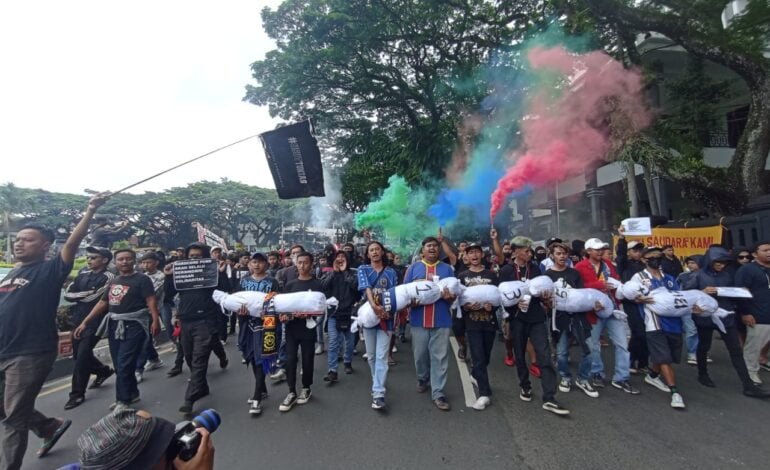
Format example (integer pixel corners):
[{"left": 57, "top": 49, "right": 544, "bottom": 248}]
[{"left": 457, "top": 244, "right": 498, "bottom": 410}]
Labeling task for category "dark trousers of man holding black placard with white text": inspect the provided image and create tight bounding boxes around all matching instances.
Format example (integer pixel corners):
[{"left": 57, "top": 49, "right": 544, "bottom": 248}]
[{"left": 182, "top": 320, "right": 216, "bottom": 402}]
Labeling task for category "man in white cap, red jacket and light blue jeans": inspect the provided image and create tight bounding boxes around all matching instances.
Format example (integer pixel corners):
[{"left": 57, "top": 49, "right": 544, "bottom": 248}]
[{"left": 575, "top": 238, "right": 639, "bottom": 395}]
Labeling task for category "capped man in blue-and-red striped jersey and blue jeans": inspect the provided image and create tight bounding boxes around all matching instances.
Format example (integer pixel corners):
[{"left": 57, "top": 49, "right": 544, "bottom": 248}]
[{"left": 404, "top": 237, "right": 454, "bottom": 411}]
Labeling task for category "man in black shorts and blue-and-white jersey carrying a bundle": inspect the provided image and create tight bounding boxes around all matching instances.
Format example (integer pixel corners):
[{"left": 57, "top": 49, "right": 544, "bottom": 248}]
[{"left": 632, "top": 246, "right": 685, "bottom": 409}]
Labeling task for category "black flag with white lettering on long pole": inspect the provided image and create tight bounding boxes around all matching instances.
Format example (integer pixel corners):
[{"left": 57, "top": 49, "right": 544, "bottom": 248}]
[{"left": 259, "top": 121, "right": 325, "bottom": 199}]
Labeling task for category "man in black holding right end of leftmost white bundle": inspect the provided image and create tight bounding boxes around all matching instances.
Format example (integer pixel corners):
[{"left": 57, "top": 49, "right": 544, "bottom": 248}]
[{"left": 278, "top": 253, "right": 323, "bottom": 411}]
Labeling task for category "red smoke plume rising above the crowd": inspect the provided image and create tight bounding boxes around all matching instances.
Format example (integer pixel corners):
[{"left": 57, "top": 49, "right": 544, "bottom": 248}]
[{"left": 489, "top": 47, "right": 652, "bottom": 220}]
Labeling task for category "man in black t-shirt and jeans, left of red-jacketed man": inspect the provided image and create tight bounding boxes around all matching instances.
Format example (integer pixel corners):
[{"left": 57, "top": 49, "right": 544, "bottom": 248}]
[{"left": 545, "top": 242, "right": 599, "bottom": 398}]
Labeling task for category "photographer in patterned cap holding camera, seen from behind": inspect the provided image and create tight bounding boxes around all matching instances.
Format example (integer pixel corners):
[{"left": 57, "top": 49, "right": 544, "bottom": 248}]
[{"left": 59, "top": 409, "right": 220, "bottom": 470}]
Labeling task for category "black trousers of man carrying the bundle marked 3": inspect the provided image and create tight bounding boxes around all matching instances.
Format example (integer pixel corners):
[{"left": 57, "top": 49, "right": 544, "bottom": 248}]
[{"left": 510, "top": 318, "right": 556, "bottom": 402}]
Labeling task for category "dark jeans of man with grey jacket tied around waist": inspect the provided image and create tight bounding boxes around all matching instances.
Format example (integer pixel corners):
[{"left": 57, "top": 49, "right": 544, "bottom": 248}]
[{"left": 108, "top": 320, "right": 147, "bottom": 403}]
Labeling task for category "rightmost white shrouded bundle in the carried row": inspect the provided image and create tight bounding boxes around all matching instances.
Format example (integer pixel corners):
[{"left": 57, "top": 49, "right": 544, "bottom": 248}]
[{"left": 644, "top": 287, "right": 732, "bottom": 332}]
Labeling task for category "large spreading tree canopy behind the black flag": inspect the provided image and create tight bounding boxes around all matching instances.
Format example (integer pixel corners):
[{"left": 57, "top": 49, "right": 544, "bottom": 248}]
[{"left": 245, "top": 0, "right": 545, "bottom": 208}]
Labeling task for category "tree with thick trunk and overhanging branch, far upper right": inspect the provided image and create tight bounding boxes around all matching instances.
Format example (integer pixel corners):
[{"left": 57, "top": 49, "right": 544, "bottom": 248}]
[{"left": 576, "top": 0, "right": 770, "bottom": 199}]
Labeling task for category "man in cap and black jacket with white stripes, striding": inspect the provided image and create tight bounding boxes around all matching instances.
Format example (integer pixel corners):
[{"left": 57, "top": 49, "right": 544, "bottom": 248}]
[{"left": 64, "top": 246, "right": 115, "bottom": 410}]
